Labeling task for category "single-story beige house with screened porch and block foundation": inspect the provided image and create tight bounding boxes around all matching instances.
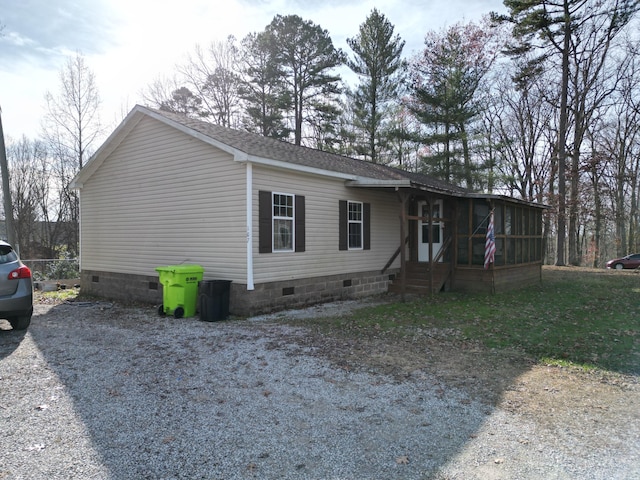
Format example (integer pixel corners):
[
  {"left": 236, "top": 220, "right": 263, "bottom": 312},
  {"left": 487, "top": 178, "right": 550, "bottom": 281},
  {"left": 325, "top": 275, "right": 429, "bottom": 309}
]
[{"left": 73, "top": 106, "right": 544, "bottom": 315}]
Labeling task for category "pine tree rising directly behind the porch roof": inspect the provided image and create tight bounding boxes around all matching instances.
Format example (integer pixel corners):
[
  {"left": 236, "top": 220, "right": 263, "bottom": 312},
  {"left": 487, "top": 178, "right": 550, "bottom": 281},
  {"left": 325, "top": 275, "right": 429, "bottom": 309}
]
[{"left": 410, "top": 23, "right": 496, "bottom": 189}]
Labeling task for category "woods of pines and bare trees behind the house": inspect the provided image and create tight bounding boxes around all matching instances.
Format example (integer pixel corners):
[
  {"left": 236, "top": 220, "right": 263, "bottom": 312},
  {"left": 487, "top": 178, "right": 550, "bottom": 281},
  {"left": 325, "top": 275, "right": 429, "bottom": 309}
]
[{"left": 7, "top": 0, "right": 640, "bottom": 267}]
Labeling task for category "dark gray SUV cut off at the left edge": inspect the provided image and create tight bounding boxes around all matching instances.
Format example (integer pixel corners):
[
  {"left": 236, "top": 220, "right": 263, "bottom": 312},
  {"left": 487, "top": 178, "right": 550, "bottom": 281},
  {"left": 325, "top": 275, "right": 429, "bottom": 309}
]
[{"left": 0, "top": 240, "right": 33, "bottom": 330}]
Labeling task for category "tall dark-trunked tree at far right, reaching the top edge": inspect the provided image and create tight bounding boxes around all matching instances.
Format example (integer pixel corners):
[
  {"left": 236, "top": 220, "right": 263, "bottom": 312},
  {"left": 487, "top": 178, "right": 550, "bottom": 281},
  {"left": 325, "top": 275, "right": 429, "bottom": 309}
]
[{"left": 503, "top": 0, "right": 640, "bottom": 266}]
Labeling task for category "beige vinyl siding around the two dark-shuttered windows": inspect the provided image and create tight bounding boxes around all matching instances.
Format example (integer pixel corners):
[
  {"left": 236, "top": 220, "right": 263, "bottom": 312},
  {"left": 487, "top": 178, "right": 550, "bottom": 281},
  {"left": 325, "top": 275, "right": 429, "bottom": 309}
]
[{"left": 253, "top": 166, "right": 400, "bottom": 284}]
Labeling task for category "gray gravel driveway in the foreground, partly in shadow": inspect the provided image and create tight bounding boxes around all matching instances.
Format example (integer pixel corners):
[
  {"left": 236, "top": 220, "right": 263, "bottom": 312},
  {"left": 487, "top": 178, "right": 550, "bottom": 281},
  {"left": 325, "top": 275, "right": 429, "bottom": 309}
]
[{"left": 0, "top": 302, "right": 640, "bottom": 480}]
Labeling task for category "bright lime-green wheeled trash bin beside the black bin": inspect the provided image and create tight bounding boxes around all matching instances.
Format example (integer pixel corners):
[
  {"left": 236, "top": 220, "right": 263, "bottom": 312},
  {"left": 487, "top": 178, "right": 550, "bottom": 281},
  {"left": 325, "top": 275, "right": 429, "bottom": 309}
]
[{"left": 156, "top": 265, "right": 204, "bottom": 318}]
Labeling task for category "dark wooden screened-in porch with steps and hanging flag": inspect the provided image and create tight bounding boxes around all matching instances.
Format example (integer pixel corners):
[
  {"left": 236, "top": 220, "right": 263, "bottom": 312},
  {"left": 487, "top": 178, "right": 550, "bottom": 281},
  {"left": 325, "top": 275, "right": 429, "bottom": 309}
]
[{"left": 360, "top": 183, "right": 547, "bottom": 294}]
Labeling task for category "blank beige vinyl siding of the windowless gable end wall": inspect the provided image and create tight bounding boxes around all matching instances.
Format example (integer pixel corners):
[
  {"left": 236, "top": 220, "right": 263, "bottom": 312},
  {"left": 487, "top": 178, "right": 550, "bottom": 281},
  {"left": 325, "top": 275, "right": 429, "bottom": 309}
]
[{"left": 81, "top": 118, "right": 246, "bottom": 283}]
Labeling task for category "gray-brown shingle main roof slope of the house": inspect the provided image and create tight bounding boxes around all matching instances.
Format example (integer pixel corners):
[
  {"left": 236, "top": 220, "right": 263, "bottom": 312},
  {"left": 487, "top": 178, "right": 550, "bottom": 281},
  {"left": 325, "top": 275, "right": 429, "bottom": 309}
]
[{"left": 145, "top": 107, "right": 470, "bottom": 195}]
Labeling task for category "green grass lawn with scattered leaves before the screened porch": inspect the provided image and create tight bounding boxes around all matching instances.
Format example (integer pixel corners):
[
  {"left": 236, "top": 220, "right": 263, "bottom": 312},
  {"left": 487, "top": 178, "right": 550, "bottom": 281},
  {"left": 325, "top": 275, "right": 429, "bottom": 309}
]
[{"left": 302, "top": 267, "right": 640, "bottom": 375}]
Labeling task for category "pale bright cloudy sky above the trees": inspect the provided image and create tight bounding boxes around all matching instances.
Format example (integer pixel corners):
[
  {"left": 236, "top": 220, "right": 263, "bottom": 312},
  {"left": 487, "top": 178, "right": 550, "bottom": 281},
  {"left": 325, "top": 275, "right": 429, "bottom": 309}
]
[{"left": 0, "top": 0, "right": 506, "bottom": 140}]
